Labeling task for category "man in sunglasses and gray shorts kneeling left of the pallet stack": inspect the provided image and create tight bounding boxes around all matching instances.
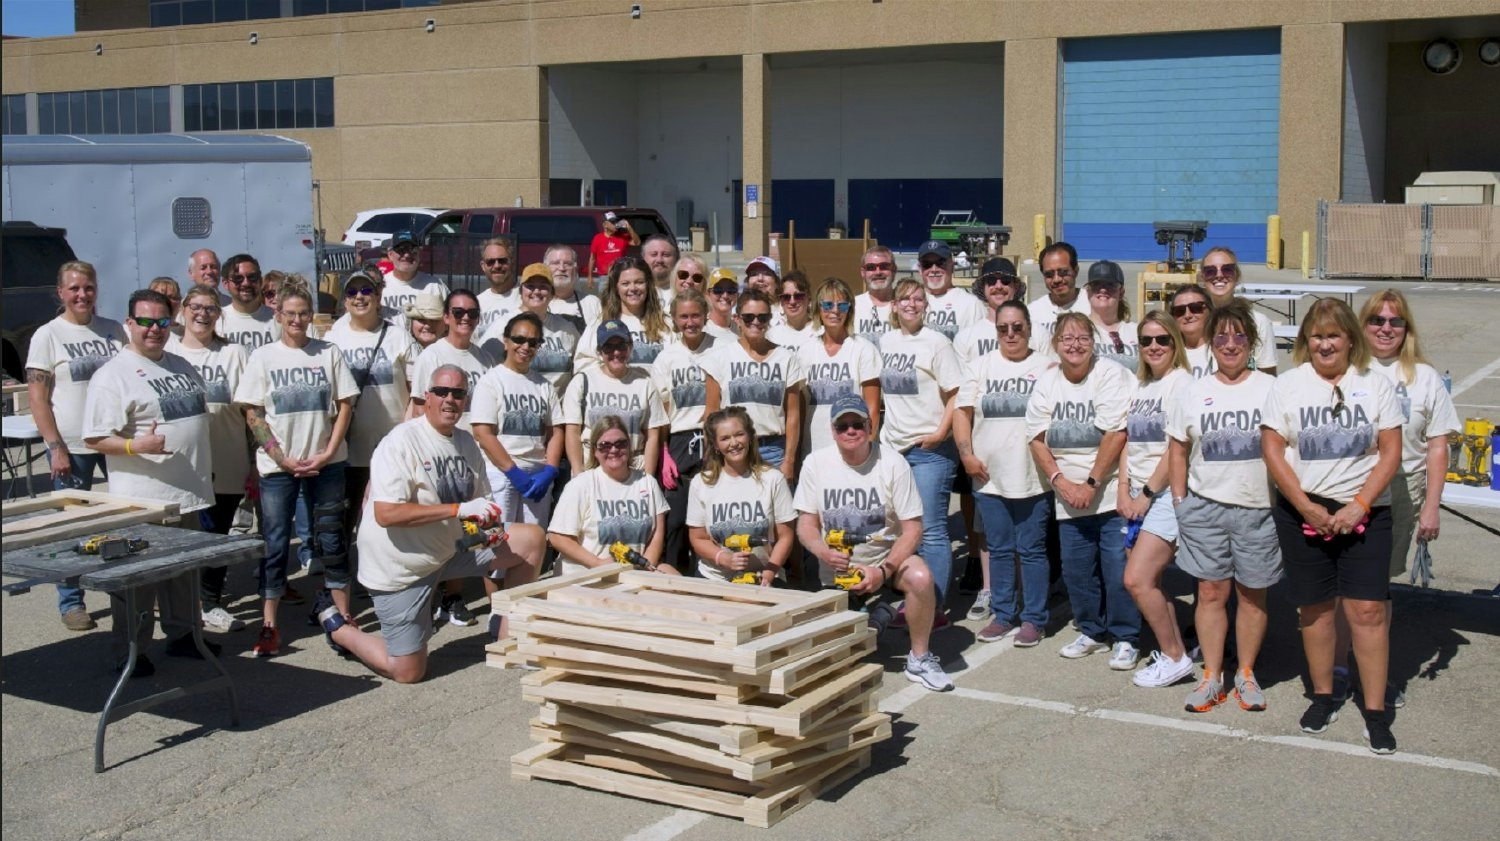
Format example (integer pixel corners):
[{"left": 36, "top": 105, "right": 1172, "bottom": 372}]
[{"left": 314, "top": 364, "right": 546, "bottom": 684}]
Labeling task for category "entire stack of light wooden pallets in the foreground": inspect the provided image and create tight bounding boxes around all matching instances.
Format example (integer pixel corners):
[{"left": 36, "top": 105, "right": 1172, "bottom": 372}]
[{"left": 488, "top": 567, "right": 891, "bottom": 826}]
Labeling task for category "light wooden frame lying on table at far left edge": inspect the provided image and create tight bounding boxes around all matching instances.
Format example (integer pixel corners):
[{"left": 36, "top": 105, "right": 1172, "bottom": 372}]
[{"left": 0, "top": 490, "right": 180, "bottom": 550}]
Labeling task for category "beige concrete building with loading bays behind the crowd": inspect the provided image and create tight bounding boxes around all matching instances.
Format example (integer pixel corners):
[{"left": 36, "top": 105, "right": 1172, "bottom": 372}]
[{"left": 0, "top": 0, "right": 1500, "bottom": 265}]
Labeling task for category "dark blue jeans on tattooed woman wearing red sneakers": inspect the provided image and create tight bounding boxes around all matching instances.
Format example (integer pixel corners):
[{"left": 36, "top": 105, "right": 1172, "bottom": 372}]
[{"left": 257, "top": 462, "right": 350, "bottom": 598}]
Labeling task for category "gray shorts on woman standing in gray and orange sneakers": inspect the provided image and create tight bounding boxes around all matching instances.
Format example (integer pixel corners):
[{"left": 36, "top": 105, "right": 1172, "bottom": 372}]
[{"left": 1176, "top": 493, "right": 1281, "bottom": 589}]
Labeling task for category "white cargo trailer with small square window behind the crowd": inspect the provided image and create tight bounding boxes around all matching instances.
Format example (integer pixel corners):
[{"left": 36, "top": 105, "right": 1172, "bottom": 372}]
[{"left": 0, "top": 133, "right": 315, "bottom": 319}]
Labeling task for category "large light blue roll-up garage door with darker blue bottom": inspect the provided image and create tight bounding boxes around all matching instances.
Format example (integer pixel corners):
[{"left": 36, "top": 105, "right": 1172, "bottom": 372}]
[{"left": 1061, "top": 30, "right": 1281, "bottom": 261}]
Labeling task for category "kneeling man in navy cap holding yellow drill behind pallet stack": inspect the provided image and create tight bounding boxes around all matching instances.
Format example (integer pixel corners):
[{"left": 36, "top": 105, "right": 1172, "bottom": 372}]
[{"left": 794, "top": 394, "right": 953, "bottom": 693}]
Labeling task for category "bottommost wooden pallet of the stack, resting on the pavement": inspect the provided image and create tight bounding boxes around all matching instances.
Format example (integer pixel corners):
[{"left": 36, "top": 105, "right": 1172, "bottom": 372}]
[{"left": 510, "top": 742, "right": 870, "bottom": 828}]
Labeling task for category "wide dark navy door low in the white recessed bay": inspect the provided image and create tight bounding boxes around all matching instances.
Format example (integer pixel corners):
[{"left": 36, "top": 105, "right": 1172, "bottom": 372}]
[{"left": 849, "top": 178, "right": 1001, "bottom": 250}]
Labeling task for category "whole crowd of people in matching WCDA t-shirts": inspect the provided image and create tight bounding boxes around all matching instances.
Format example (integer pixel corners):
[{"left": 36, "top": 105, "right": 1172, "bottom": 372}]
[{"left": 27, "top": 234, "right": 1457, "bottom": 743}]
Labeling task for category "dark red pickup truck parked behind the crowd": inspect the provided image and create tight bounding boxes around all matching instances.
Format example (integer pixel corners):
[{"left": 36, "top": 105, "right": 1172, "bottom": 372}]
[{"left": 360, "top": 207, "right": 675, "bottom": 289}]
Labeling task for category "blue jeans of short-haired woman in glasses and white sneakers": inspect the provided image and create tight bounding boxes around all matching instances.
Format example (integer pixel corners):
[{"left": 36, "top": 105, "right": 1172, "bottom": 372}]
[{"left": 1056, "top": 511, "right": 1140, "bottom": 645}]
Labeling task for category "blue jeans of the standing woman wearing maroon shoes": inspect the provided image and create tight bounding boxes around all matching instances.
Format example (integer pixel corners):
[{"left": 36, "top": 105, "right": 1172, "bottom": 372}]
[{"left": 974, "top": 493, "right": 1052, "bottom": 628}]
